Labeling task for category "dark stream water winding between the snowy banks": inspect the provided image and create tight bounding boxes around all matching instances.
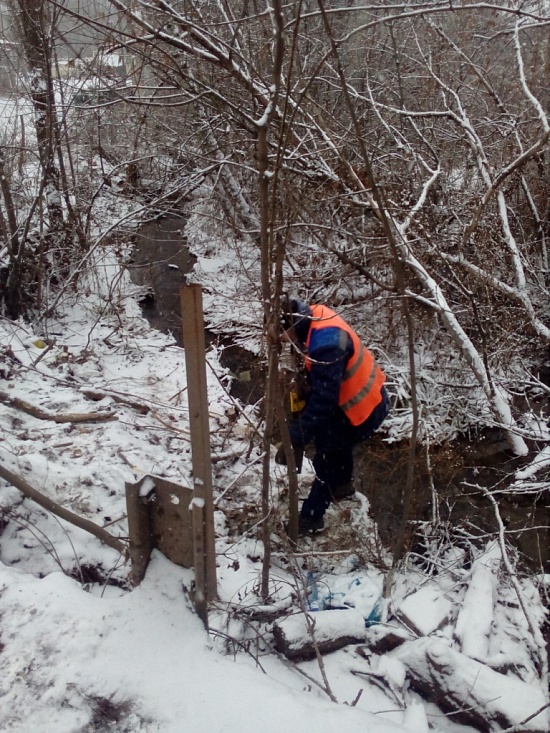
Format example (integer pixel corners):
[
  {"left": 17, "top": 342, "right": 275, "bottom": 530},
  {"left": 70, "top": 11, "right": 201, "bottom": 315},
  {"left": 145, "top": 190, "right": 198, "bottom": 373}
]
[{"left": 129, "top": 217, "right": 550, "bottom": 573}]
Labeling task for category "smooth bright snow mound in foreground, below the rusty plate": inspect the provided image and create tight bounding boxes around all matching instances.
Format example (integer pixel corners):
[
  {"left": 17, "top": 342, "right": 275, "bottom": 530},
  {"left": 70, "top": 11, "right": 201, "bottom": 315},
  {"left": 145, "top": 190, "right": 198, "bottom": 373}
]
[{"left": 2, "top": 555, "right": 402, "bottom": 733}]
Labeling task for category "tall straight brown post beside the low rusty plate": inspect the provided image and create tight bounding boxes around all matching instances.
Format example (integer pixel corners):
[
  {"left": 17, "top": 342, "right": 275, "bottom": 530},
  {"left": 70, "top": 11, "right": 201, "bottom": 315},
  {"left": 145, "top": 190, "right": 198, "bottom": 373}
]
[{"left": 180, "top": 285, "right": 218, "bottom": 625}]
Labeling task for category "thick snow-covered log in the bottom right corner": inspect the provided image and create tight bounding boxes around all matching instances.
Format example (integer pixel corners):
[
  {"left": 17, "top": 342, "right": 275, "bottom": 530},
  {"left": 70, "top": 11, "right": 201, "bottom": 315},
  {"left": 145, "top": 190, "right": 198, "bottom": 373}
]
[{"left": 395, "top": 638, "right": 549, "bottom": 733}]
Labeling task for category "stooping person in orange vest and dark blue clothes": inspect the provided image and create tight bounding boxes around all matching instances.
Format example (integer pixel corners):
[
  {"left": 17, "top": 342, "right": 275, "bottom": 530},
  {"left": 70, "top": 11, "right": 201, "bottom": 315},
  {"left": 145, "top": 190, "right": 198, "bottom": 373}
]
[{"left": 275, "top": 299, "right": 389, "bottom": 534}]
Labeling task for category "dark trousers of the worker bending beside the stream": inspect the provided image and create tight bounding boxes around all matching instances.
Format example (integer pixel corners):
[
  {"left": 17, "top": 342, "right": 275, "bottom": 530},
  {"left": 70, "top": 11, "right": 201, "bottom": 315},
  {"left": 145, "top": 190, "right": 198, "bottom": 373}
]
[{"left": 300, "top": 387, "right": 390, "bottom": 519}]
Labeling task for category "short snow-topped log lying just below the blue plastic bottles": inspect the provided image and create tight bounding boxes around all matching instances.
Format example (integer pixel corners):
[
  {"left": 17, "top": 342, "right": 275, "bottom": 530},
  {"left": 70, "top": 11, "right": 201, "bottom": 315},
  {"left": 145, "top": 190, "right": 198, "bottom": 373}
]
[{"left": 273, "top": 608, "right": 366, "bottom": 661}]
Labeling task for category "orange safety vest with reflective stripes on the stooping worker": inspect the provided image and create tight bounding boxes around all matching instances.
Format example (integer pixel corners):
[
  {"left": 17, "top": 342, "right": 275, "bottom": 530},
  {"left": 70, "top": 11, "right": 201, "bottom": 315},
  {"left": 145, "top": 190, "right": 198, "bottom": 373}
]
[{"left": 305, "top": 305, "right": 386, "bottom": 425}]
